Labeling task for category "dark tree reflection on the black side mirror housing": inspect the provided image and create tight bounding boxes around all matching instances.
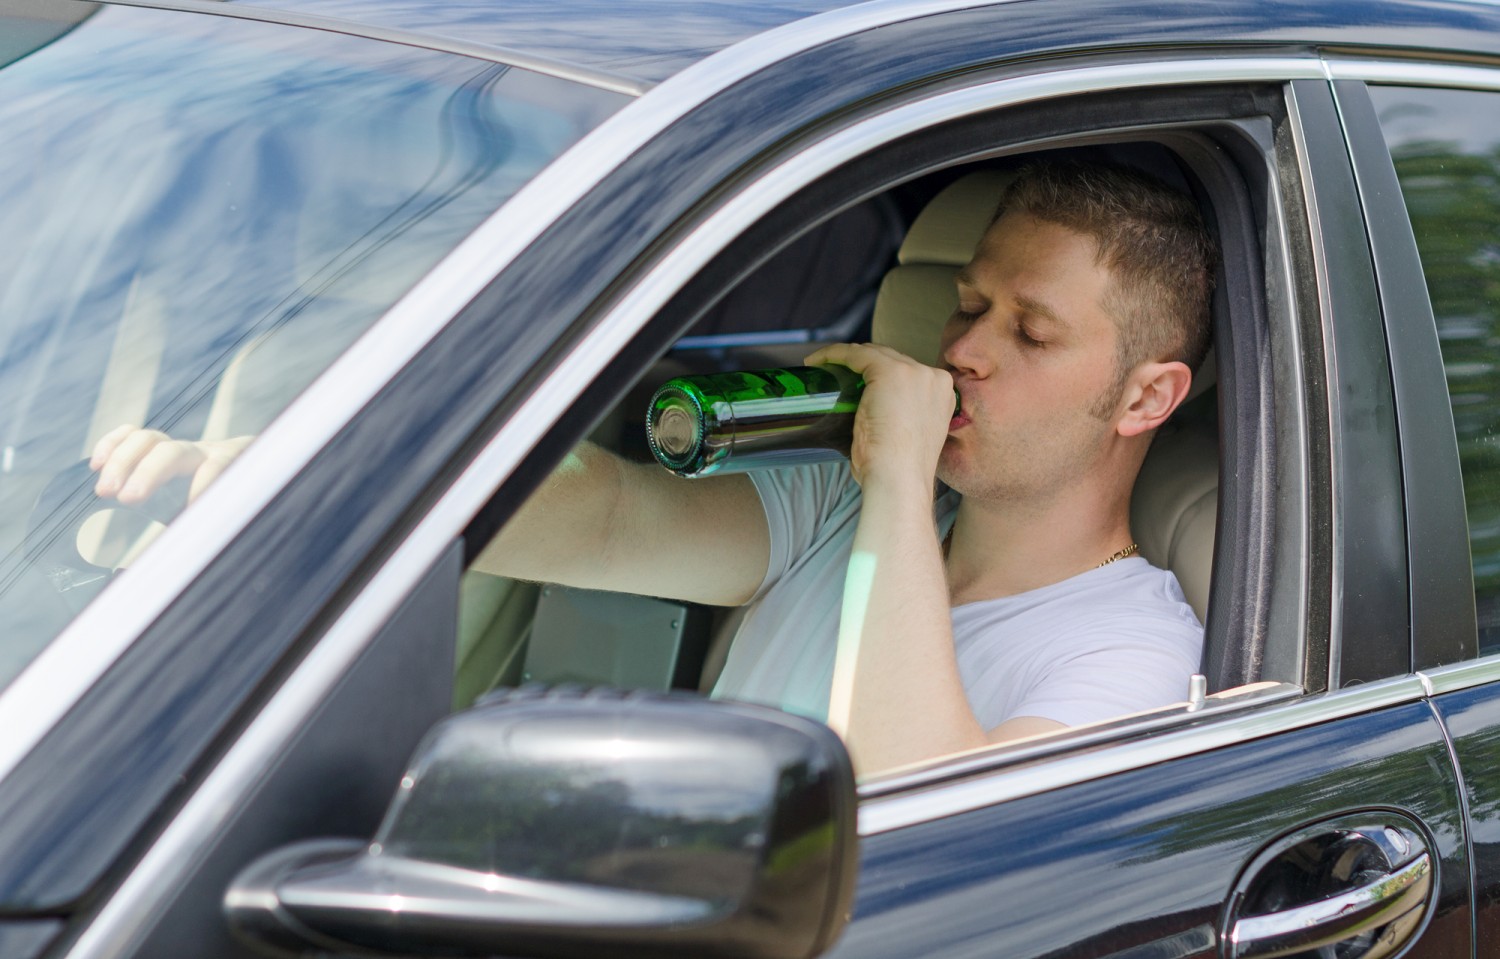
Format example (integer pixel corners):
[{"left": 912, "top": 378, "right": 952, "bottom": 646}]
[{"left": 384, "top": 764, "right": 765, "bottom": 902}]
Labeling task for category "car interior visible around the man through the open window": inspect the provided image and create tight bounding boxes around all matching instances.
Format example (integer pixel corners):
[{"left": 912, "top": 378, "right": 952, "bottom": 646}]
[{"left": 455, "top": 135, "right": 1283, "bottom": 768}]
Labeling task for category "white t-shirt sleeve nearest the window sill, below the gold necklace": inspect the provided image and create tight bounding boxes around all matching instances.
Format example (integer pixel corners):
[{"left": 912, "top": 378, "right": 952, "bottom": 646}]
[{"left": 1005, "top": 617, "right": 1203, "bottom": 726}]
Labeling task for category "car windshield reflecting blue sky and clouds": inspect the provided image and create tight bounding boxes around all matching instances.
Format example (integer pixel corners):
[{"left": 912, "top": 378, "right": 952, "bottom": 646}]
[{"left": 0, "top": 0, "right": 624, "bottom": 687}]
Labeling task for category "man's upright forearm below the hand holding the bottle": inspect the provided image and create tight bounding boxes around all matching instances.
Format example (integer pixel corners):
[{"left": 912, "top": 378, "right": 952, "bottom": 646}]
[{"left": 830, "top": 480, "right": 987, "bottom": 773}]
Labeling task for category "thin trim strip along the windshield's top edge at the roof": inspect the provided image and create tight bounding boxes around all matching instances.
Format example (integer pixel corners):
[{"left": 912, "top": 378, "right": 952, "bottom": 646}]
[{"left": 104, "top": 0, "right": 651, "bottom": 96}]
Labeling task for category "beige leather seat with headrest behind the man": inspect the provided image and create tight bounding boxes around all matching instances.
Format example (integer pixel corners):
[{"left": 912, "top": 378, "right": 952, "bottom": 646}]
[{"left": 872, "top": 171, "right": 1218, "bottom": 620}]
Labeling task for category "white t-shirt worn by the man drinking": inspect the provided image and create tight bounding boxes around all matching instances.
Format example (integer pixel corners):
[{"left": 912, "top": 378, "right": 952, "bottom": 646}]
[{"left": 714, "top": 462, "right": 1203, "bottom": 729}]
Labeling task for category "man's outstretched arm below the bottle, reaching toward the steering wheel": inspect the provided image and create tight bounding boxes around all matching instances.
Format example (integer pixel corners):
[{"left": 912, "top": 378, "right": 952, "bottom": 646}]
[{"left": 474, "top": 443, "right": 771, "bottom": 606}]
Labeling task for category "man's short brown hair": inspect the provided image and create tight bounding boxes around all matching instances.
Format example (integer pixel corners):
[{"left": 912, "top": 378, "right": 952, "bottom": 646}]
[{"left": 995, "top": 161, "right": 1218, "bottom": 376}]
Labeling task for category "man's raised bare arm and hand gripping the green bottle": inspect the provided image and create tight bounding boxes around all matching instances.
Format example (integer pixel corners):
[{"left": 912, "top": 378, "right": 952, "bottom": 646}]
[{"left": 807, "top": 345, "right": 1064, "bottom": 774}]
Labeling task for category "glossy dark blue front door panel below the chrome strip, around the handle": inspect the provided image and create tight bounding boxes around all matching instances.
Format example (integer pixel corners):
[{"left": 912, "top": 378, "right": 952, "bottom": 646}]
[{"left": 833, "top": 702, "right": 1470, "bottom": 959}]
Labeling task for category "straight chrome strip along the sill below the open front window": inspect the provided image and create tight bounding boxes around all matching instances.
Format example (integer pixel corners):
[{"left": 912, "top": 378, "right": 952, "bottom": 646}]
[{"left": 860, "top": 677, "right": 1422, "bottom": 836}]
